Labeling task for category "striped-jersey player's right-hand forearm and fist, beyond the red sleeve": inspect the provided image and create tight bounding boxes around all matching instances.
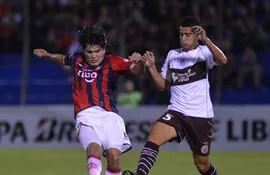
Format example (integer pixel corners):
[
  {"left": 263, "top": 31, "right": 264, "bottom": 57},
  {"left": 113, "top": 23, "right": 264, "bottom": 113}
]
[{"left": 129, "top": 52, "right": 144, "bottom": 75}]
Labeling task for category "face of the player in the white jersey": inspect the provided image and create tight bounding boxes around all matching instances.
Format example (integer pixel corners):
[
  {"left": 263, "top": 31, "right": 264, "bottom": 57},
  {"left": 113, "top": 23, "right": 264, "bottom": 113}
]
[{"left": 179, "top": 27, "right": 198, "bottom": 50}]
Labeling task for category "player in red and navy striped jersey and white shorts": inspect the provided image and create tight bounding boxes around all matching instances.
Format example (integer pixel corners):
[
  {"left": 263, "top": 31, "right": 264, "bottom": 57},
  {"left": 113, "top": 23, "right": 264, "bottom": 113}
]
[{"left": 34, "top": 26, "right": 144, "bottom": 175}]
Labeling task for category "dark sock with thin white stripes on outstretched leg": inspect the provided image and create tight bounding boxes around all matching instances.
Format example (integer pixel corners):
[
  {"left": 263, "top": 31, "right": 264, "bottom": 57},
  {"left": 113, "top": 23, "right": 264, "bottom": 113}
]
[{"left": 137, "top": 142, "right": 159, "bottom": 175}]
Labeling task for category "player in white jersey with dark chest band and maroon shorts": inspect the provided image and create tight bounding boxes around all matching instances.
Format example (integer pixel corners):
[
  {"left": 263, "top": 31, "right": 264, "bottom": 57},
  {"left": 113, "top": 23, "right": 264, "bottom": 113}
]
[{"left": 124, "top": 17, "right": 227, "bottom": 175}]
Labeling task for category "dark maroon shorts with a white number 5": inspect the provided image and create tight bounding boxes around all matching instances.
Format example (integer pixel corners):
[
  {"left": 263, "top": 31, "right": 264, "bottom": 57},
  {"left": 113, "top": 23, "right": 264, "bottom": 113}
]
[{"left": 157, "top": 110, "right": 213, "bottom": 155}]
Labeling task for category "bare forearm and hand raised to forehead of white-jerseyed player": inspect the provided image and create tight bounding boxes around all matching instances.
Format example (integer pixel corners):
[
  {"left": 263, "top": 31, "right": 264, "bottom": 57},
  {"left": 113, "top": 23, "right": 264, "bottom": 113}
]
[{"left": 192, "top": 26, "right": 227, "bottom": 64}]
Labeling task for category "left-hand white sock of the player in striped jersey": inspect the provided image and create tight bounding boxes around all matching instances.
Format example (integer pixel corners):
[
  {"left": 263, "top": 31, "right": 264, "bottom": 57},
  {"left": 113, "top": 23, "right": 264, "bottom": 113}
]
[{"left": 87, "top": 157, "right": 102, "bottom": 175}]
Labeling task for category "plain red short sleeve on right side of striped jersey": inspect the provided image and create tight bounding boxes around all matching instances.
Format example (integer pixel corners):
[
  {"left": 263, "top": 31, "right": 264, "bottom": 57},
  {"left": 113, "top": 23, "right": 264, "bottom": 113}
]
[{"left": 109, "top": 55, "right": 132, "bottom": 75}]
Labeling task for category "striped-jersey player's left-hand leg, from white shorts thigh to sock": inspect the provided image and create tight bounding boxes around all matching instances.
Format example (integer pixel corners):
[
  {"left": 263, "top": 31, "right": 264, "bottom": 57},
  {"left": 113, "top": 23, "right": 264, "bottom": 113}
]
[{"left": 78, "top": 125, "right": 102, "bottom": 175}]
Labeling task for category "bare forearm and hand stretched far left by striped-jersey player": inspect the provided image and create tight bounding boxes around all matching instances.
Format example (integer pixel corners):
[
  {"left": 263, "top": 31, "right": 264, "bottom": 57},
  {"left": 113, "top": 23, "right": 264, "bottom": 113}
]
[{"left": 34, "top": 49, "right": 65, "bottom": 64}]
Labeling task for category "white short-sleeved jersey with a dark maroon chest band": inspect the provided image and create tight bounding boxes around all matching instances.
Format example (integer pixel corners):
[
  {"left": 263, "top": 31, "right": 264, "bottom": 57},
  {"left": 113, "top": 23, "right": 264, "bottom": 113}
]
[{"left": 161, "top": 45, "right": 216, "bottom": 118}]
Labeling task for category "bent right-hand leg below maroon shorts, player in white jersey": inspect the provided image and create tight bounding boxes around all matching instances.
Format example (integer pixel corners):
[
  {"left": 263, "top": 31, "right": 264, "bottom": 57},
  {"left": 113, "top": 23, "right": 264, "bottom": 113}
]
[{"left": 193, "top": 154, "right": 217, "bottom": 175}]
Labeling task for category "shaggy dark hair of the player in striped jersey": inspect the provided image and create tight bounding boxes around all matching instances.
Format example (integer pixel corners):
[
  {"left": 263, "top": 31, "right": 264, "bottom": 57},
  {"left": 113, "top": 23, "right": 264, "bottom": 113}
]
[{"left": 78, "top": 25, "right": 108, "bottom": 49}]
